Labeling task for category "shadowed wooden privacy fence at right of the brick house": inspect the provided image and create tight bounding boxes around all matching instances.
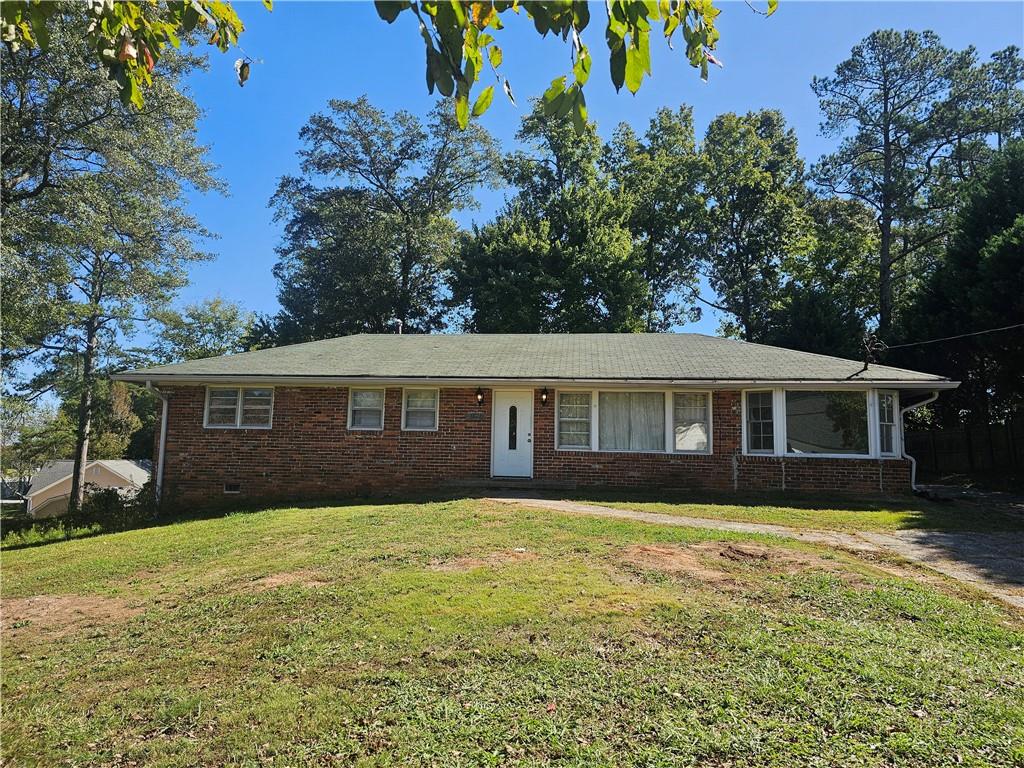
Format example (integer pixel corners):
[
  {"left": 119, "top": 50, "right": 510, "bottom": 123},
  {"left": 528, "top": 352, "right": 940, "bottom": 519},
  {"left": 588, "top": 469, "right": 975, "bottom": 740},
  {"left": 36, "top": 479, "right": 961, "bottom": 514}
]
[{"left": 904, "top": 415, "right": 1024, "bottom": 473}]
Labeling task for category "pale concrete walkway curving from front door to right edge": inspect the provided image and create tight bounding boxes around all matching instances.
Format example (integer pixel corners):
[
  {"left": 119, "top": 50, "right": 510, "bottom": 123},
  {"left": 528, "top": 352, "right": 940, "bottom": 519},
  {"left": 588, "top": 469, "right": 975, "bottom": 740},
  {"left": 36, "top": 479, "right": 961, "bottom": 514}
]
[{"left": 488, "top": 496, "right": 1024, "bottom": 609}]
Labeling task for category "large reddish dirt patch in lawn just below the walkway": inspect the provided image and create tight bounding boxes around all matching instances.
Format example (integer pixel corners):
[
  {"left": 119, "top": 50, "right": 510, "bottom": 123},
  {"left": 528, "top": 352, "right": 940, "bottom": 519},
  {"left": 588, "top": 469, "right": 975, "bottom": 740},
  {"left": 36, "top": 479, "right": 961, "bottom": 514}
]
[{"left": 621, "top": 542, "right": 841, "bottom": 587}]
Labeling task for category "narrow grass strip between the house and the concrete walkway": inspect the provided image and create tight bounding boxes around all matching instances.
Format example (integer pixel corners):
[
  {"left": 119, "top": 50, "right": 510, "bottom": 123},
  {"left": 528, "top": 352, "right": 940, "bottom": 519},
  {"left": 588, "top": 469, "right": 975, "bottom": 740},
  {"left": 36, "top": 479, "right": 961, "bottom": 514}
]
[{"left": 565, "top": 492, "right": 1024, "bottom": 531}]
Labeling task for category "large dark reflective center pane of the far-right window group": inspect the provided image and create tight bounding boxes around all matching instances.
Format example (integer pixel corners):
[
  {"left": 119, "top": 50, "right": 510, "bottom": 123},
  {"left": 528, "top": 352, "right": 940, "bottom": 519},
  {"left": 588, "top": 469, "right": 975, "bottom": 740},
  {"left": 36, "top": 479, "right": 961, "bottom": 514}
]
[{"left": 785, "top": 390, "right": 869, "bottom": 456}]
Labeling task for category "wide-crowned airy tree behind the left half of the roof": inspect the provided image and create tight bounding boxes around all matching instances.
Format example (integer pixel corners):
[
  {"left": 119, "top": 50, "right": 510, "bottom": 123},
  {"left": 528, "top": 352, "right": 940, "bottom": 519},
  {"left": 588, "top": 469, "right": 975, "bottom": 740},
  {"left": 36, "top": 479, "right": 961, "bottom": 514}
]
[{"left": 272, "top": 97, "right": 497, "bottom": 343}]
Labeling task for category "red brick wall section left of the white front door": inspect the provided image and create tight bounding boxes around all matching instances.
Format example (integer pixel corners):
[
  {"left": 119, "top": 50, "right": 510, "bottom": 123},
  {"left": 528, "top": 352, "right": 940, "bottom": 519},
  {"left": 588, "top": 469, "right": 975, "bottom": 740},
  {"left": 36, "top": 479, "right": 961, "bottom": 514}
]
[{"left": 164, "top": 387, "right": 490, "bottom": 502}]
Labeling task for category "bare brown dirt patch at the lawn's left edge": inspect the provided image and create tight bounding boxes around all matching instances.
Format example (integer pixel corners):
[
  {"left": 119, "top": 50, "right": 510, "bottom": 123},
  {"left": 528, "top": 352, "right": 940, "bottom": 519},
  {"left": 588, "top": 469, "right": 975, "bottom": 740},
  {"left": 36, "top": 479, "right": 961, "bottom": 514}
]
[{"left": 0, "top": 595, "right": 142, "bottom": 638}]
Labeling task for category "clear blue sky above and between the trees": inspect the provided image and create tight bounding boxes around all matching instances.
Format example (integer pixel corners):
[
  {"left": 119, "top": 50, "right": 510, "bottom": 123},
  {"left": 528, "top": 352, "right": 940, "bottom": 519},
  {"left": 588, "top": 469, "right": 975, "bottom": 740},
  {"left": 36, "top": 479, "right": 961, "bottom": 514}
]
[{"left": 180, "top": 0, "right": 1024, "bottom": 333}]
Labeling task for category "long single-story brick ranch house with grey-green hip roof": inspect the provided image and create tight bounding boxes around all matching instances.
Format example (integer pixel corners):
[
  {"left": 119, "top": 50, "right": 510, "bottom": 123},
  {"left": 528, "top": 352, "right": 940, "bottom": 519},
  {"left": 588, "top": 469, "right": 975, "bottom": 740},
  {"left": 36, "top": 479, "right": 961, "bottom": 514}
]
[{"left": 116, "top": 334, "right": 957, "bottom": 503}]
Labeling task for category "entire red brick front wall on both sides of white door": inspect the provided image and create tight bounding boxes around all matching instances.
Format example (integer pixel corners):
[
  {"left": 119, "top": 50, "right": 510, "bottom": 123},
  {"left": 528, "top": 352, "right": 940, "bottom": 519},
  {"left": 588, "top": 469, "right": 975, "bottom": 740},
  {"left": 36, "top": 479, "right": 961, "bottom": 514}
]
[{"left": 155, "top": 387, "right": 910, "bottom": 504}]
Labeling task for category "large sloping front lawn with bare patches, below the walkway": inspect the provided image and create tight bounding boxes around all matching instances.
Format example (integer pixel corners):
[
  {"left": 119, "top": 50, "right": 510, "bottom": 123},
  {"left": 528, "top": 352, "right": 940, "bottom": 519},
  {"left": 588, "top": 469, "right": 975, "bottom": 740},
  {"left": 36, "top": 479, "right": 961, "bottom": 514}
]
[{"left": 6, "top": 500, "right": 1024, "bottom": 766}]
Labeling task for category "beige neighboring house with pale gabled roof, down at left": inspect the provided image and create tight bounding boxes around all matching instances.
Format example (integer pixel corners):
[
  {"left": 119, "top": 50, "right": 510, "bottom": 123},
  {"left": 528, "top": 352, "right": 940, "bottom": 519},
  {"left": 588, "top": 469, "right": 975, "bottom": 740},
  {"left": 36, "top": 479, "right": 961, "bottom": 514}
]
[{"left": 25, "top": 459, "right": 150, "bottom": 517}]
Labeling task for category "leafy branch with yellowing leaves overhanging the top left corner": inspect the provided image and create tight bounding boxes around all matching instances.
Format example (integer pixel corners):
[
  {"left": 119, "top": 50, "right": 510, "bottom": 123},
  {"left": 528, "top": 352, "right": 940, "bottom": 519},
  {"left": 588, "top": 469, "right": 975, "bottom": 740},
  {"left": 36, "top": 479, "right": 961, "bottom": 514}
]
[{"left": 0, "top": 0, "right": 272, "bottom": 109}]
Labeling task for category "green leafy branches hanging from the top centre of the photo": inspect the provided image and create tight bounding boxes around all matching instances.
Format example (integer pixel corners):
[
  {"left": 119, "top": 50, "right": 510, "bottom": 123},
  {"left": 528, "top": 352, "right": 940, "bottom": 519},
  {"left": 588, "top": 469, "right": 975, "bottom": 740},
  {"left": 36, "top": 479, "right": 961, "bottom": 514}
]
[{"left": 375, "top": 0, "right": 761, "bottom": 132}]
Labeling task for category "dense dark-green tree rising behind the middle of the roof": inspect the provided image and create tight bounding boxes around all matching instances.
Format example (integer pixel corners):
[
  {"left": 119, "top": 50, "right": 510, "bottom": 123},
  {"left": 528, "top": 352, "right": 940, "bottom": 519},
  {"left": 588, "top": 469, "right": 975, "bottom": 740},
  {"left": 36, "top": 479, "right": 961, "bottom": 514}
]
[{"left": 452, "top": 102, "right": 649, "bottom": 333}]
